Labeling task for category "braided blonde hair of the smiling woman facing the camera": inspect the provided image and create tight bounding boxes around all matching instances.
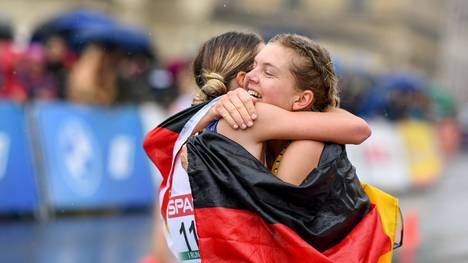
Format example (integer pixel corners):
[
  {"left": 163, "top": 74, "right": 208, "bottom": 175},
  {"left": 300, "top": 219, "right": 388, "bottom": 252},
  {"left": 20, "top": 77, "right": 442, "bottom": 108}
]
[{"left": 269, "top": 34, "right": 340, "bottom": 111}]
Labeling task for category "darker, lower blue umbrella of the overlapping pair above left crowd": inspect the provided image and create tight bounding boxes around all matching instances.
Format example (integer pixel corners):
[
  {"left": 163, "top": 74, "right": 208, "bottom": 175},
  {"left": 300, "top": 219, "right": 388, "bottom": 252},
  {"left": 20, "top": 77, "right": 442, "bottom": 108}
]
[{"left": 72, "top": 25, "right": 153, "bottom": 57}]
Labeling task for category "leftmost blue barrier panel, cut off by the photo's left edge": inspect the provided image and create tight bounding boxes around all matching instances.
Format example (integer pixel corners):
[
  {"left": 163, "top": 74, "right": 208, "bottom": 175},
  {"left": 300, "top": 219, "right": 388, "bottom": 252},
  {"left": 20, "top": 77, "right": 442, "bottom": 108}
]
[{"left": 0, "top": 101, "right": 39, "bottom": 213}]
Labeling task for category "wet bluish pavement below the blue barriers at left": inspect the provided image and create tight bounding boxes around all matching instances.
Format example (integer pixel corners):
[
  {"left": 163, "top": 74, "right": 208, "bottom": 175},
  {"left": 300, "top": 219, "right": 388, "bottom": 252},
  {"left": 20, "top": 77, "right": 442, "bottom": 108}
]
[{"left": 0, "top": 212, "right": 152, "bottom": 263}]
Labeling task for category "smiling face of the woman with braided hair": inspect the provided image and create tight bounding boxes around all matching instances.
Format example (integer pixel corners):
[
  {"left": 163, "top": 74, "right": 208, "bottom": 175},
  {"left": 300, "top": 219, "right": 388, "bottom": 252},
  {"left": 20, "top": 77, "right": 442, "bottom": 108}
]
[{"left": 245, "top": 43, "right": 302, "bottom": 110}]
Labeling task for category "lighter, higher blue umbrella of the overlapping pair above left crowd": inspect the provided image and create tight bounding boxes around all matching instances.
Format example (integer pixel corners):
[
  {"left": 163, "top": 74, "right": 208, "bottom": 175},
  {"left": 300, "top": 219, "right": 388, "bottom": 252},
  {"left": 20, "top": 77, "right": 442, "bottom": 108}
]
[{"left": 31, "top": 10, "right": 115, "bottom": 43}]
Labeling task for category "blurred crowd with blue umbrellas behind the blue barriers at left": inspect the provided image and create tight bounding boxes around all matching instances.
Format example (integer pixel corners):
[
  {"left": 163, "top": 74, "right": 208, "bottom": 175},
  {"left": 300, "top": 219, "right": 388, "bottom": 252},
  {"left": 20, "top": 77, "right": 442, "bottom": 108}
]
[{"left": 0, "top": 11, "right": 188, "bottom": 109}]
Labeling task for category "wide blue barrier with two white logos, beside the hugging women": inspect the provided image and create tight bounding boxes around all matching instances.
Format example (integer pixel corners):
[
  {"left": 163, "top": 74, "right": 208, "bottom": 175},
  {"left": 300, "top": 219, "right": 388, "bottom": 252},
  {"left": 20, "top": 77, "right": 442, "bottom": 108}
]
[{"left": 33, "top": 103, "right": 154, "bottom": 210}]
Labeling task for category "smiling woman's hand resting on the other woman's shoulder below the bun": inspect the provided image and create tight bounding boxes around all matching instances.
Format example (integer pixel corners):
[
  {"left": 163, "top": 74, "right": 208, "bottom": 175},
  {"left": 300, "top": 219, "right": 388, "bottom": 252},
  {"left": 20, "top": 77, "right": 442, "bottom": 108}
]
[{"left": 212, "top": 88, "right": 258, "bottom": 129}]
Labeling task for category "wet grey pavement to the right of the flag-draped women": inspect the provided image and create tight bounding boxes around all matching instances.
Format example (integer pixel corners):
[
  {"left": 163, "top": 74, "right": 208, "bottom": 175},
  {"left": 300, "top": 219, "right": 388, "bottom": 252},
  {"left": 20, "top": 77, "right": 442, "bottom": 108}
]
[{"left": 398, "top": 152, "right": 468, "bottom": 263}]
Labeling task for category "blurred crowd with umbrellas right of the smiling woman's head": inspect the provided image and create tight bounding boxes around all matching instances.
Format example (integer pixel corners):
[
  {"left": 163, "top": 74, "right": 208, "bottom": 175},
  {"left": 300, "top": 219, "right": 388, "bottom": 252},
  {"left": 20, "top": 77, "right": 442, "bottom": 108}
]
[{"left": 340, "top": 69, "right": 462, "bottom": 156}]
